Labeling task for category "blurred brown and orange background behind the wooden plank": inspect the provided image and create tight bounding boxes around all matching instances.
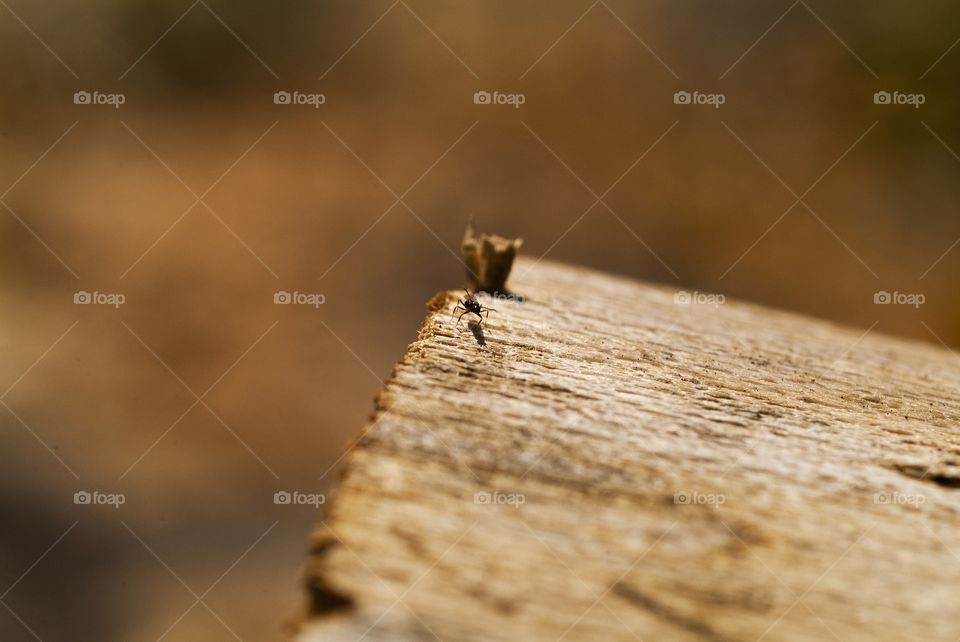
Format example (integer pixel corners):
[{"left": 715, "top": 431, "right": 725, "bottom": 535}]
[{"left": 0, "top": 0, "right": 960, "bottom": 641}]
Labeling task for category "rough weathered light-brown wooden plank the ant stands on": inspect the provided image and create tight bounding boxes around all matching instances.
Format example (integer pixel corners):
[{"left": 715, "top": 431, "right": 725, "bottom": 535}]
[{"left": 299, "top": 261, "right": 960, "bottom": 642}]
